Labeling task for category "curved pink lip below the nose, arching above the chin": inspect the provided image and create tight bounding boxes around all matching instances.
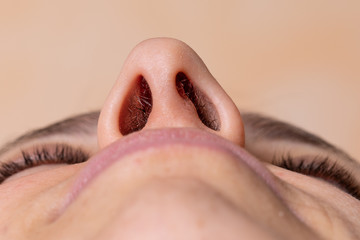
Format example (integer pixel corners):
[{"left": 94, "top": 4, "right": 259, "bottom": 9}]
[{"left": 57, "top": 128, "right": 279, "bottom": 220}]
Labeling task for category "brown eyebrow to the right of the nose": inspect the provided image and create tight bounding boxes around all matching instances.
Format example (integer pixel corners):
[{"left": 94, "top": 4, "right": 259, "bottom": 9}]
[{"left": 242, "top": 113, "right": 356, "bottom": 162}]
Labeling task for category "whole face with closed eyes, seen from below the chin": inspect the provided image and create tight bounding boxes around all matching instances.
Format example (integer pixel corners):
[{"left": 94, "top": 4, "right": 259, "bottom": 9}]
[{"left": 0, "top": 39, "right": 360, "bottom": 240}]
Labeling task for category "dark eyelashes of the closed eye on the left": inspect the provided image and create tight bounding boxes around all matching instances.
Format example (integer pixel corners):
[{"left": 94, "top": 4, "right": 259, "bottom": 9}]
[{"left": 0, "top": 144, "right": 90, "bottom": 183}]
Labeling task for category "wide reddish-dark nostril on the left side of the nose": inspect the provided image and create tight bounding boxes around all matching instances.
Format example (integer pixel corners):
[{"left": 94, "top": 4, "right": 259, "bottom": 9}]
[{"left": 119, "top": 76, "right": 152, "bottom": 135}]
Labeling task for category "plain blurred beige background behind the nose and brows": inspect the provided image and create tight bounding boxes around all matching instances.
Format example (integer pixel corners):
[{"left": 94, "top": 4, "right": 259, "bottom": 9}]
[{"left": 0, "top": 0, "right": 360, "bottom": 158}]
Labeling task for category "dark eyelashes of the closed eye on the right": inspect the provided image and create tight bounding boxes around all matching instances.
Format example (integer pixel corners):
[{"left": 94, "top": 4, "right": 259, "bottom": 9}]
[{"left": 275, "top": 156, "right": 360, "bottom": 200}]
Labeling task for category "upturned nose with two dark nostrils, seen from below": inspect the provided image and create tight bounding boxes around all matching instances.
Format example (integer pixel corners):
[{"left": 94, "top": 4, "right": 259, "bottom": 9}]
[{"left": 98, "top": 38, "right": 244, "bottom": 148}]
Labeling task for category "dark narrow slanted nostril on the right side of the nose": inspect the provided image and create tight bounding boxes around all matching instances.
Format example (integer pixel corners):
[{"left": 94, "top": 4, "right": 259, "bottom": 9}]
[{"left": 176, "top": 72, "right": 221, "bottom": 131}]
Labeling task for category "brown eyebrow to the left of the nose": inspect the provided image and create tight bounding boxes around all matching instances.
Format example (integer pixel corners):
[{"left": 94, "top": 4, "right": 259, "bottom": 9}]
[{"left": 0, "top": 111, "right": 100, "bottom": 156}]
